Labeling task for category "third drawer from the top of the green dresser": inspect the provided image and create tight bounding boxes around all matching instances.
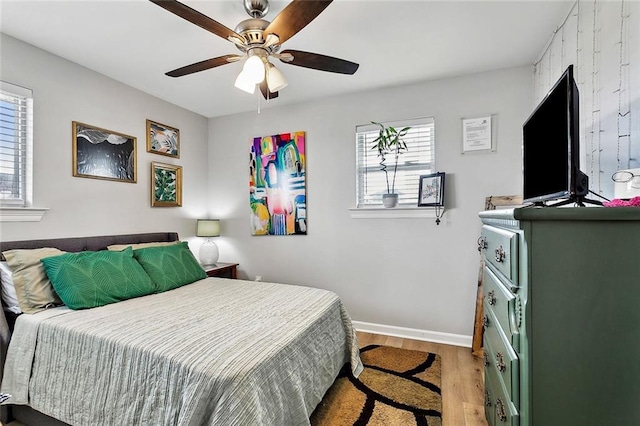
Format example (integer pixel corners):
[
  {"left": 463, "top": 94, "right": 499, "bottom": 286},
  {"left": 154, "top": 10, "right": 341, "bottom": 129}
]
[{"left": 484, "top": 304, "right": 520, "bottom": 407}]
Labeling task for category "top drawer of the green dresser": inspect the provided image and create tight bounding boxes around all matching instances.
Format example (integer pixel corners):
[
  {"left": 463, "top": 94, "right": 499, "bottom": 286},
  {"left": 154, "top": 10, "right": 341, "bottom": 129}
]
[{"left": 481, "top": 225, "right": 518, "bottom": 286}]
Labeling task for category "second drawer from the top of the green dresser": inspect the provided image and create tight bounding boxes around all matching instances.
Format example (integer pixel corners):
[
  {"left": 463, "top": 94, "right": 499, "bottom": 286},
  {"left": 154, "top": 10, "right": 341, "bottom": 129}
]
[{"left": 482, "top": 267, "right": 521, "bottom": 342}]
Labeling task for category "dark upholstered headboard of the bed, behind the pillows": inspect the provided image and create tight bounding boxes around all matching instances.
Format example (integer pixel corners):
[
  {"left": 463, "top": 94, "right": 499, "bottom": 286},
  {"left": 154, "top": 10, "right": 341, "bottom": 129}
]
[{"left": 0, "top": 232, "right": 178, "bottom": 421}]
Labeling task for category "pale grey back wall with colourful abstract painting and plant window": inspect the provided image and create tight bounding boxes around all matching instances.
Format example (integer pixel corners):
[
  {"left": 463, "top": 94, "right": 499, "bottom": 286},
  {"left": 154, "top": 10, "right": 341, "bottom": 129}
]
[{"left": 209, "top": 67, "right": 533, "bottom": 336}]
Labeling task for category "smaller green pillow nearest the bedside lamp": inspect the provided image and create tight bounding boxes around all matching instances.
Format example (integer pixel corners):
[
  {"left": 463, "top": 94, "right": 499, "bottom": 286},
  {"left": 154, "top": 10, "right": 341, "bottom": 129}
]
[{"left": 133, "top": 241, "right": 207, "bottom": 292}]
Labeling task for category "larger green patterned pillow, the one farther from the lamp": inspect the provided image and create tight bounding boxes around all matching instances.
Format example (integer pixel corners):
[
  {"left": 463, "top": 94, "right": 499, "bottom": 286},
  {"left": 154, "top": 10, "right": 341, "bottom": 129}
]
[{"left": 42, "top": 247, "right": 156, "bottom": 309}]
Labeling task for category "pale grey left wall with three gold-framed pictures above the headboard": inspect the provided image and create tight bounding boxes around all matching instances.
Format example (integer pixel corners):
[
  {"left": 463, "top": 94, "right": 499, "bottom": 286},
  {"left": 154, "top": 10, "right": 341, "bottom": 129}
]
[{"left": 0, "top": 34, "right": 208, "bottom": 241}]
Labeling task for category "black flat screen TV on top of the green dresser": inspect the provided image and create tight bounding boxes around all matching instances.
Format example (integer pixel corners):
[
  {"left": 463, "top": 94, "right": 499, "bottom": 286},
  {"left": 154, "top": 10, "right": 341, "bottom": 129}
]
[{"left": 522, "top": 65, "right": 589, "bottom": 205}]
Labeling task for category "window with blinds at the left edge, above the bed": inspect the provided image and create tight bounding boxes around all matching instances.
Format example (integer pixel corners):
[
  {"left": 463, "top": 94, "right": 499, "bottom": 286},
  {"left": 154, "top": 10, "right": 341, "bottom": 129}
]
[{"left": 0, "top": 82, "right": 33, "bottom": 207}]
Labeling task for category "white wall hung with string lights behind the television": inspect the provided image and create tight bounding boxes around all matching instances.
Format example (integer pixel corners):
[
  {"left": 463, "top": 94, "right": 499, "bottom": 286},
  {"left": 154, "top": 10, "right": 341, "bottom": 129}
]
[{"left": 535, "top": 0, "right": 640, "bottom": 199}]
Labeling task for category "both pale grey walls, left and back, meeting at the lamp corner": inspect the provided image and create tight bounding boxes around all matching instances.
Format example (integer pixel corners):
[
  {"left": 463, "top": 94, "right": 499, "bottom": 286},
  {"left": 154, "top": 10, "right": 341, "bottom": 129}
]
[{"left": 0, "top": 31, "right": 533, "bottom": 342}]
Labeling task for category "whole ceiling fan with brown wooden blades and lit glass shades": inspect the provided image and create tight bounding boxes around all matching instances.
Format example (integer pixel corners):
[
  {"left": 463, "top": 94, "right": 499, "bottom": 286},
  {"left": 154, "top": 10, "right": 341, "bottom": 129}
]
[{"left": 150, "top": 0, "right": 359, "bottom": 99}]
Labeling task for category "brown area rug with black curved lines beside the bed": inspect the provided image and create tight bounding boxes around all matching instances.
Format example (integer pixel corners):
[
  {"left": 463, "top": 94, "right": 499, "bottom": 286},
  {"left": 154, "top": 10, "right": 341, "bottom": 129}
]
[{"left": 311, "top": 345, "right": 442, "bottom": 426}]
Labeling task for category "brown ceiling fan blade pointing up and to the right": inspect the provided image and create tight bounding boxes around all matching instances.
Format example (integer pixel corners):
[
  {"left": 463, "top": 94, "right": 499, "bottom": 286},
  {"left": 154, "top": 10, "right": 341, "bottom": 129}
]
[{"left": 264, "top": 0, "right": 333, "bottom": 44}]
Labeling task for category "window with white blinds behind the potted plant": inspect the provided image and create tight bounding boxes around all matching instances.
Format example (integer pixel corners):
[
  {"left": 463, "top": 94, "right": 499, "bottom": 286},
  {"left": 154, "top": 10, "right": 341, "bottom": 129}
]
[{"left": 356, "top": 117, "right": 435, "bottom": 208}]
